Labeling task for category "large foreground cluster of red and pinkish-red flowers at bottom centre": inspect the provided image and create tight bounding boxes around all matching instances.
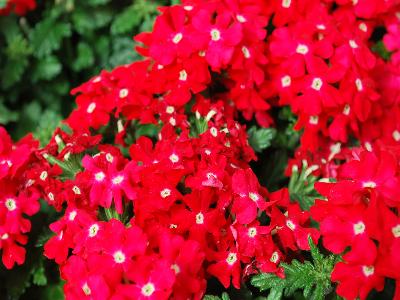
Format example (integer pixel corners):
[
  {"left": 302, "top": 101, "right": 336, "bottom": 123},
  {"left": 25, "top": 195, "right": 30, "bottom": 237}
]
[{"left": 45, "top": 99, "right": 319, "bottom": 299}]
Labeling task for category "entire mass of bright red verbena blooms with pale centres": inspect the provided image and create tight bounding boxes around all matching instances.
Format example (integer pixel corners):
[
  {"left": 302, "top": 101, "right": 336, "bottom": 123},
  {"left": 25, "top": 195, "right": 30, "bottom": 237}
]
[{"left": 0, "top": 0, "right": 400, "bottom": 299}]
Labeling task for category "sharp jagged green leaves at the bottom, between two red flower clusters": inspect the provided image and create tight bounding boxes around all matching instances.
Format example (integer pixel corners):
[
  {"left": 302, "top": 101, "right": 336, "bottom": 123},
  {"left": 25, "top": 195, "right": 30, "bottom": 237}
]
[{"left": 251, "top": 237, "right": 339, "bottom": 300}]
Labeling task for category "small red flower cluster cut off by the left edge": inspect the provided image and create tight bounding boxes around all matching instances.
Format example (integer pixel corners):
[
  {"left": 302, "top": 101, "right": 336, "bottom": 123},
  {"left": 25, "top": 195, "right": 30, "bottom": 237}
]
[{"left": 0, "top": 127, "right": 40, "bottom": 269}]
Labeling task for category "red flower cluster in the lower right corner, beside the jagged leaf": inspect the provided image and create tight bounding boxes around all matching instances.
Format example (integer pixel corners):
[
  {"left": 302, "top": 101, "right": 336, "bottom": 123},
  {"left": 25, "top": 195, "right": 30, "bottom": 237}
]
[{"left": 311, "top": 148, "right": 400, "bottom": 299}]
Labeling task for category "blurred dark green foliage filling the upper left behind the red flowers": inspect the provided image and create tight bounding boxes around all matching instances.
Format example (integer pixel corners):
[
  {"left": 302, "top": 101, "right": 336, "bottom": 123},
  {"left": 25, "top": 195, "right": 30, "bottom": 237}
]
[{"left": 0, "top": 0, "right": 170, "bottom": 142}]
